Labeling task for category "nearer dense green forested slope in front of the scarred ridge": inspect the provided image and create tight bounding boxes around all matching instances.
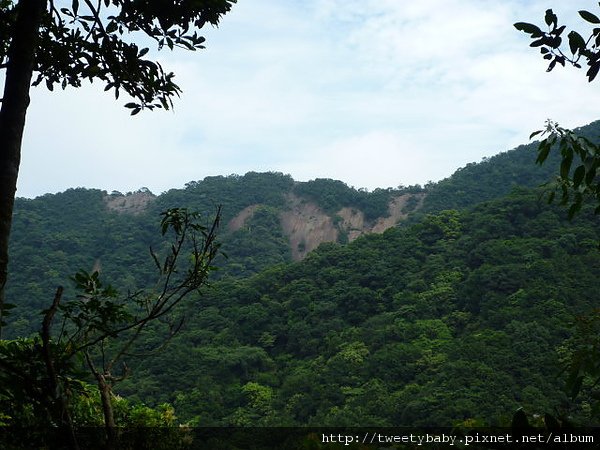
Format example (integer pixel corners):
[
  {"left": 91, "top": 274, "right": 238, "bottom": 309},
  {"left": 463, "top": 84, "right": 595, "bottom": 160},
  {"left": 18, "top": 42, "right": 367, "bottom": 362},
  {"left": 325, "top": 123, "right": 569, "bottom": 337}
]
[{"left": 116, "top": 191, "right": 600, "bottom": 426}]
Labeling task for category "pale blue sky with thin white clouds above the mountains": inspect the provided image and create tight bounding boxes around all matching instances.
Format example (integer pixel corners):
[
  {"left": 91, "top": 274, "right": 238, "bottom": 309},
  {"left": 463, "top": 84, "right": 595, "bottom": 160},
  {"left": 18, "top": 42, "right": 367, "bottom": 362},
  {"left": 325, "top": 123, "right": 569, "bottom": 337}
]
[{"left": 17, "top": 0, "right": 600, "bottom": 198}]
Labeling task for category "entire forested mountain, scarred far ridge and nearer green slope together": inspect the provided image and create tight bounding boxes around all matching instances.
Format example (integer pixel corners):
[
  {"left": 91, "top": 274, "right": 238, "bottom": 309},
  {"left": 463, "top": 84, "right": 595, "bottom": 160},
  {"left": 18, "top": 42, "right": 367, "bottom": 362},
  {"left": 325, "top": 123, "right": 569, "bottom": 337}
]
[{"left": 7, "top": 118, "right": 600, "bottom": 426}]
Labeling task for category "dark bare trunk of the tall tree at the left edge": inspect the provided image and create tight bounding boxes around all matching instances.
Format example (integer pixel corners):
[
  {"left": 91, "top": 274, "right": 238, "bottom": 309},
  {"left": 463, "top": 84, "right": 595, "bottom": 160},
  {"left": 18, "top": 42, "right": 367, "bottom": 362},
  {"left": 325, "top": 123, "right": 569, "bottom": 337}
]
[{"left": 0, "top": 0, "right": 47, "bottom": 338}]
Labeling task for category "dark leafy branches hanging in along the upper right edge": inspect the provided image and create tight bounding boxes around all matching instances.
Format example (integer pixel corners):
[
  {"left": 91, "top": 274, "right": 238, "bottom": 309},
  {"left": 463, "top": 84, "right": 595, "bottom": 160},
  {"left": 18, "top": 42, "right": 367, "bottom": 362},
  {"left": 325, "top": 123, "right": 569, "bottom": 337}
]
[{"left": 514, "top": 9, "right": 600, "bottom": 218}]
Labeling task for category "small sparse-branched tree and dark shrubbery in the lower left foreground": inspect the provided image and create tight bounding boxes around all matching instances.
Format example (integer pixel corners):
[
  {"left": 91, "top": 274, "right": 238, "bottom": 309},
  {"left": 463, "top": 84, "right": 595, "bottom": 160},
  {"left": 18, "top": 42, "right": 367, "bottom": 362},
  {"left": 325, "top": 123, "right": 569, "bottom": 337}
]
[{"left": 0, "top": 208, "right": 221, "bottom": 448}]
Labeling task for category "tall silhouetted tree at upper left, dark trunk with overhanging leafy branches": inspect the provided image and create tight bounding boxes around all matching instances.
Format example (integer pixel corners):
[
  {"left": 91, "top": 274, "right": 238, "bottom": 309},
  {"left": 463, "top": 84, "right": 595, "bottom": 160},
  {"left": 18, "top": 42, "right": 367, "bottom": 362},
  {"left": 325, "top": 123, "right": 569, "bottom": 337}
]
[{"left": 0, "top": 0, "right": 236, "bottom": 330}]
